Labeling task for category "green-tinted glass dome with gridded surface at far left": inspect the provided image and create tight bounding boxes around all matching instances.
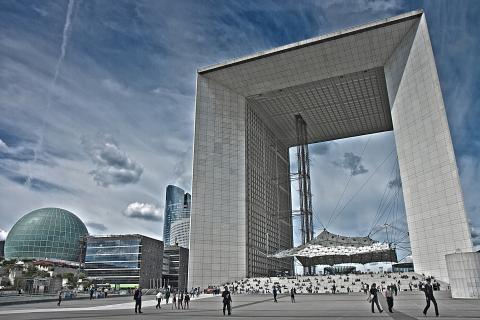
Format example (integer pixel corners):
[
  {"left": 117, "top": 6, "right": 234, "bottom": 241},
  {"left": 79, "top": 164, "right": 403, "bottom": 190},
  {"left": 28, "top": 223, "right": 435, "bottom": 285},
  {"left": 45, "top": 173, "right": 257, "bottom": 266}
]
[{"left": 5, "top": 208, "right": 88, "bottom": 262}]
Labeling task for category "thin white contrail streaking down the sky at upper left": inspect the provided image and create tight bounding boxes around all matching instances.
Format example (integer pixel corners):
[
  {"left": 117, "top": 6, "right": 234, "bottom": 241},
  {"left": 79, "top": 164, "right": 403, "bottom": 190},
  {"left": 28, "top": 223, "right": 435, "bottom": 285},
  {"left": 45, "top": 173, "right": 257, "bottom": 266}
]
[{"left": 25, "top": 0, "right": 75, "bottom": 186}]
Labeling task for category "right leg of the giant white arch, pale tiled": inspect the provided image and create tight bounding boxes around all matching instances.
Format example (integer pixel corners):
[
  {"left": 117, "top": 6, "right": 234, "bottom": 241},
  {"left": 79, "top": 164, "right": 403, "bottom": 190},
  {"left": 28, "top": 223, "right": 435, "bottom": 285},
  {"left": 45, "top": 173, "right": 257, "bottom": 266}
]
[{"left": 385, "top": 16, "right": 472, "bottom": 282}]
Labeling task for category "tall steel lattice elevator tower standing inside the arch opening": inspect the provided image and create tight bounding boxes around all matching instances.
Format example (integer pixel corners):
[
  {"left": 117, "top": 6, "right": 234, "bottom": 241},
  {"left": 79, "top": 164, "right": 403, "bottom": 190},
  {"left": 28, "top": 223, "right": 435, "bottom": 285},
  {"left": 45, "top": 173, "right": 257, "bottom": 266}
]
[{"left": 295, "top": 114, "right": 315, "bottom": 275}]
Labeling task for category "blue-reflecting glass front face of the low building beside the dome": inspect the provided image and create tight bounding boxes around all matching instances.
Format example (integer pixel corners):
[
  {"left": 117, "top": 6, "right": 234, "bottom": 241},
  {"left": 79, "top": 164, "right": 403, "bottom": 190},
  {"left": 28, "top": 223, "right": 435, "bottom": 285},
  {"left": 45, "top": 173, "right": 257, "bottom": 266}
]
[{"left": 85, "top": 236, "right": 142, "bottom": 284}]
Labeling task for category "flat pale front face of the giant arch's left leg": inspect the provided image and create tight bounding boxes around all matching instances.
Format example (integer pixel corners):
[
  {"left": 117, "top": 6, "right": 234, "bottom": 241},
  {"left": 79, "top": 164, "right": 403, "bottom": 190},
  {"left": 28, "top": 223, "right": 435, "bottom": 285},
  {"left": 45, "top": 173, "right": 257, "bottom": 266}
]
[{"left": 188, "top": 75, "right": 246, "bottom": 288}]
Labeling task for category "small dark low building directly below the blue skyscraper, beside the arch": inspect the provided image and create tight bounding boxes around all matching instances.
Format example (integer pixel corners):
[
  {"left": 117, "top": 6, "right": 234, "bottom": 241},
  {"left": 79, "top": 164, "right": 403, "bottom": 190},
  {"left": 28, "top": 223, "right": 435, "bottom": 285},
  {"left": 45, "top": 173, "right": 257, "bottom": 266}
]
[{"left": 163, "top": 245, "right": 189, "bottom": 291}]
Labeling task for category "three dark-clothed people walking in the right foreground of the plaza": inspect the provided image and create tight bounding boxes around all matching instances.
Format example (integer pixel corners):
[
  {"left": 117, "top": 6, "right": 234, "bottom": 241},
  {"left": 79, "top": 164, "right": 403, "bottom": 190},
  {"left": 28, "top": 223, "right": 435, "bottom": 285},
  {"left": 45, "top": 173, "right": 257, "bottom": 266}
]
[{"left": 367, "top": 278, "right": 439, "bottom": 317}]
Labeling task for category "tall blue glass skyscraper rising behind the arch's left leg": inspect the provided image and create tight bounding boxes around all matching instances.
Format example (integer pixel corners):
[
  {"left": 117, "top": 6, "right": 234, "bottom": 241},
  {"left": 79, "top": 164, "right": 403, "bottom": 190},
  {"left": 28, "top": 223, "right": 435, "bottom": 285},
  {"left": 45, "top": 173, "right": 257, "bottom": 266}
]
[{"left": 163, "top": 185, "right": 192, "bottom": 245}]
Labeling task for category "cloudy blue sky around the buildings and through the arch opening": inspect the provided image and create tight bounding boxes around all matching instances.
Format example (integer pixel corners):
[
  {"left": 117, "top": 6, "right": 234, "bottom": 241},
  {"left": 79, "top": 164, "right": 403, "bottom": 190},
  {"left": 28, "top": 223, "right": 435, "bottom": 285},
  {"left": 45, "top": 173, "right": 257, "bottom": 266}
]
[{"left": 0, "top": 0, "right": 480, "bottom": 258}]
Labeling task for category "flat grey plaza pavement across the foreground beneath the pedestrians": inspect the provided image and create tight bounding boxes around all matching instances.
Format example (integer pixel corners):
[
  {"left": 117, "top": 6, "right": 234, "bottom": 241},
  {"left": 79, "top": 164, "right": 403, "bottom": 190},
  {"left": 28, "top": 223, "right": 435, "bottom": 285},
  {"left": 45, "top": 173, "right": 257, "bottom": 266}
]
[{"left": 0, "top": 292, "right": 480, "bottom": 320}]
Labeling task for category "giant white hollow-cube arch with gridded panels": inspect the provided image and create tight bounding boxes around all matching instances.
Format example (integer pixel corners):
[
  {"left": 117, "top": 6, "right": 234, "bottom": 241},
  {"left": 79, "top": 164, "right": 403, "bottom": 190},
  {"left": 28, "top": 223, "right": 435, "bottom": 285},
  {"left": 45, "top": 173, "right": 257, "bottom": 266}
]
[{"left": 189, "top": 11, "right": 472, "bottom": 287}]
